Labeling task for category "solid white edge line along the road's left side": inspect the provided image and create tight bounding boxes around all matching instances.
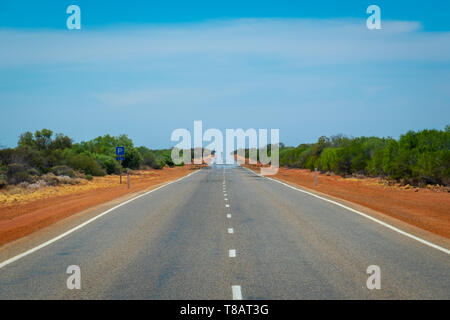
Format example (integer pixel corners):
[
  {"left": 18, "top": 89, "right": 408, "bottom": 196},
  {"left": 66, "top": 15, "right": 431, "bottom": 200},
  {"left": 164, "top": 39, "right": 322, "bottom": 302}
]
[{"left": 0, "top": 170, "right": 200, "bottom": 269}]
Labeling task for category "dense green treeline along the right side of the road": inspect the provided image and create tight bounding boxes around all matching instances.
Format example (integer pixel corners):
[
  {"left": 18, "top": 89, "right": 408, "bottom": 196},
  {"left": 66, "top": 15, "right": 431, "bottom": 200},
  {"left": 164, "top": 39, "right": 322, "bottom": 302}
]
[{"left": 255, "top": 125, "right": 450, "bottom": 186}]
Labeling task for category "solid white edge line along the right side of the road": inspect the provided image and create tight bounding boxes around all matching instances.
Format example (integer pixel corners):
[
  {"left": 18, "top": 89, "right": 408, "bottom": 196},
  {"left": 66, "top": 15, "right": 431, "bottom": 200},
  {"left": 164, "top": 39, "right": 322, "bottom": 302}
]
[{"left": 245, "top": 168, "right": 450, "bottom": 255}]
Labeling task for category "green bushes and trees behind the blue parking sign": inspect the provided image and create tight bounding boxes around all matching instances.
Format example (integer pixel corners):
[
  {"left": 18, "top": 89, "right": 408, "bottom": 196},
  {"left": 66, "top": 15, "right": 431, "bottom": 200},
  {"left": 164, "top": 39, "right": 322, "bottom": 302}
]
[{"left": 0, "top": 129, "right": 178, "bottom": 188}]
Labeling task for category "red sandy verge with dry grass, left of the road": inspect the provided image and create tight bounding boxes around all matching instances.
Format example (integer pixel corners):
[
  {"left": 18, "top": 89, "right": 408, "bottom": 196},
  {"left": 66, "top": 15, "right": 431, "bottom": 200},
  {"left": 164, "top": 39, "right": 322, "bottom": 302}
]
[{"left": 0, "top": 165, "right": 202, "bottom": 246}]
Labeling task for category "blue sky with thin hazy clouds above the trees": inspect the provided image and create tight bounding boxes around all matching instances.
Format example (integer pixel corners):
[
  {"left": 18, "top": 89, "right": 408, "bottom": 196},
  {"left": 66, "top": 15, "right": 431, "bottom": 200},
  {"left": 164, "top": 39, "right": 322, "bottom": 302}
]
[{"left": 0, "top": 0, "right": 450, "bottom": 148}]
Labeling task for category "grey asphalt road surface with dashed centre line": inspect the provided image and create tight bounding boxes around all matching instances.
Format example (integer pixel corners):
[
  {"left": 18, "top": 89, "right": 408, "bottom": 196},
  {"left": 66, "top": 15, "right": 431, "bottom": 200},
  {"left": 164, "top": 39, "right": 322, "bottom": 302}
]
[{"left": 0, "top": 166, "right": 450, "bottom": 299}]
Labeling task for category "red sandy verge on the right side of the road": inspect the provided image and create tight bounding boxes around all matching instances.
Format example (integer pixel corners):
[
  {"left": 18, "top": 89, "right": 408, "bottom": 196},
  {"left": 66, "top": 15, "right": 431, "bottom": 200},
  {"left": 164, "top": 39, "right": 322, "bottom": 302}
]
[{"left": 245, "top": 165, "right": 450, "bottom": 238}]
